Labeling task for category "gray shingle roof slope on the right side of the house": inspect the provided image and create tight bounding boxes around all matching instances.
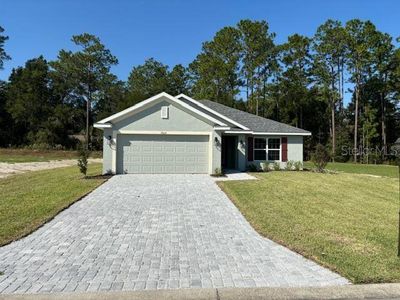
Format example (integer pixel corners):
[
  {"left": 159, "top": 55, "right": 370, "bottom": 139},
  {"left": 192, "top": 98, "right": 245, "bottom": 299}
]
[{"left": 199, "top": 100, "right": 310, "bottom": 134}]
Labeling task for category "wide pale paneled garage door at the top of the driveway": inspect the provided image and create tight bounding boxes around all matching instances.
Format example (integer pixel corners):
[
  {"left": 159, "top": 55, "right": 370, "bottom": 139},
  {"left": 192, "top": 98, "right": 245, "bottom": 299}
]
[{"left": 117, "top": 135, "right": 209, "bottom": 174}]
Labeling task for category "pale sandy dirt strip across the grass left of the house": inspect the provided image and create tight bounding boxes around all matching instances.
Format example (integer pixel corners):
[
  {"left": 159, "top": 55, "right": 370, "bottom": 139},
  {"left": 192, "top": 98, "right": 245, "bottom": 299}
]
[{"left": 0, "top": 158, "right": 102, "bottom": 178}]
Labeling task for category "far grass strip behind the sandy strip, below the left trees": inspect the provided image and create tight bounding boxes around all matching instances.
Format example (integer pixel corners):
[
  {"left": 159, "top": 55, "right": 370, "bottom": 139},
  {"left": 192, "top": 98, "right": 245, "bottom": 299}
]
[{"left": 0, "top": 148, "right": 101, "bottom": 163}]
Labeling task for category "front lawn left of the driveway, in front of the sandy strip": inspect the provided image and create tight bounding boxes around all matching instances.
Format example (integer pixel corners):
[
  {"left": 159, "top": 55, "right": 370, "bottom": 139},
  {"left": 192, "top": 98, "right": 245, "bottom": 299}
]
[{"left": 0, "top": 164, "right": 105, "bottom": 246}]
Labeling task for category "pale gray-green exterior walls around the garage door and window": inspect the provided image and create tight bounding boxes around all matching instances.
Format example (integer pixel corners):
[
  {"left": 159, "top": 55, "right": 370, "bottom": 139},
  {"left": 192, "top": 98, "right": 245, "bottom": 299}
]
[{"left": 98, "top": 99, "right": 303, "bottom": 174}]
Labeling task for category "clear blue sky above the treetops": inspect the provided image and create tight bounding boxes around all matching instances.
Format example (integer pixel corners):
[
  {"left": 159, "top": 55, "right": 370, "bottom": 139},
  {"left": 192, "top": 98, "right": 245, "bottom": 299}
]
[{"left": 0, "top": 0, "right": 400, "bottom": 80}]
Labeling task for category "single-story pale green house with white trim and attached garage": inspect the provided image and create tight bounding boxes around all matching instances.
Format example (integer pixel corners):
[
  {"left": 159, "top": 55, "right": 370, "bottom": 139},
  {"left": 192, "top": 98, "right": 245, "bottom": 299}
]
[{"left": 94, "top": 93, "right": 311, "bottom": 174}]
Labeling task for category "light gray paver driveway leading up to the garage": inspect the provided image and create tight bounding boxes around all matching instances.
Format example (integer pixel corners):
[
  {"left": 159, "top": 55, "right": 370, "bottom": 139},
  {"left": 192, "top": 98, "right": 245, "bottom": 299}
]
[{"left": 0, "top": 175, "right": 348, "bottom": 293}]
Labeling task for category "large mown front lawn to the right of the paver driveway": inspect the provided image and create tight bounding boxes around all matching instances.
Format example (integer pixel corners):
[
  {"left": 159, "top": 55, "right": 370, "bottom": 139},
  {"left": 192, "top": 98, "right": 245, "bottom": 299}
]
[{"left": 219, "top": 171, "right": 400, "bottom": 283}]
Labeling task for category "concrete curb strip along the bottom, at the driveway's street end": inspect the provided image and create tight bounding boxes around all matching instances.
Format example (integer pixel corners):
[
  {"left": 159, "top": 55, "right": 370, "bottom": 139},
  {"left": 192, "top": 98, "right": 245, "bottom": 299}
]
[{"left": 0, "top": 283, "right": 400, "bottom": 300}]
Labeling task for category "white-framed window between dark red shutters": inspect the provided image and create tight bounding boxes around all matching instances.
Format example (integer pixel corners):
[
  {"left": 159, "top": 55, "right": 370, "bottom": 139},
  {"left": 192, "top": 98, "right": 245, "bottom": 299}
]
[{"left": 253, "top": 138, "right": 281, "bottom": 161}]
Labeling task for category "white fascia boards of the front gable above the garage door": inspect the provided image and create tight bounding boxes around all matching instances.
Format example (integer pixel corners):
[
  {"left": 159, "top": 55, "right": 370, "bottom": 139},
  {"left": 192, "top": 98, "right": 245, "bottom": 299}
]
[{"left": 97, "top": 92, "right": 226, "bottom": 126}]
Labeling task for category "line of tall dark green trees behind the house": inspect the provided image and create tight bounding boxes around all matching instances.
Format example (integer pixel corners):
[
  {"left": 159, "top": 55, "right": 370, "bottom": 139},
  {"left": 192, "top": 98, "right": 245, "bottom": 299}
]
[{"left": 0, "top": 19, "right": 400, "bottom": 162}]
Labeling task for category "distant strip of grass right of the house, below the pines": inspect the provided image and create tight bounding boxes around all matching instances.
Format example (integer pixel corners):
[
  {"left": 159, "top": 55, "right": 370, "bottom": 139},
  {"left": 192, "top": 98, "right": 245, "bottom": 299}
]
[{"left": 304, "top": 162, "right": 399, "bottom": 178}]
